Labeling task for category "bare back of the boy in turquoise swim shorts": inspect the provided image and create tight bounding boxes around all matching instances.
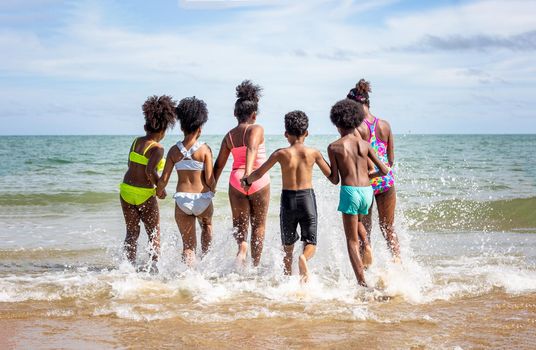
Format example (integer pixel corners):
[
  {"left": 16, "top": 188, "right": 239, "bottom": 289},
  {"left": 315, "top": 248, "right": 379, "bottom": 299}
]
[{"left": 328, "top": 134, "right": 370, "bottom": 187}]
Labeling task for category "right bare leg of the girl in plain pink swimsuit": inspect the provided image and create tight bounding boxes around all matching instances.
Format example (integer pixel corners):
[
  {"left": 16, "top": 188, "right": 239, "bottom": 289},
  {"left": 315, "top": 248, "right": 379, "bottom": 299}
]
[{"left": 249, "top": 185, "right": 270, "bottom": 266}]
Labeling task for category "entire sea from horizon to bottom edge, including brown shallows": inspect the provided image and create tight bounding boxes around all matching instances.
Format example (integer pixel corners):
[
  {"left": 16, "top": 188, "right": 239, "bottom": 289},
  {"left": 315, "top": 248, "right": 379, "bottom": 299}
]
[{"left": 0, "top": 132, "right": 536, "bottom": 349}]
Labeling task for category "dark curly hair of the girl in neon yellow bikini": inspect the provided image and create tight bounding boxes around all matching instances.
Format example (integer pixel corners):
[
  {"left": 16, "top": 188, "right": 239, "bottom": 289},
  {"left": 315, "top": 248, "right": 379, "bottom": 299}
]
[{"left": 141, "top": 95, "right": 177, "bottom": 132}]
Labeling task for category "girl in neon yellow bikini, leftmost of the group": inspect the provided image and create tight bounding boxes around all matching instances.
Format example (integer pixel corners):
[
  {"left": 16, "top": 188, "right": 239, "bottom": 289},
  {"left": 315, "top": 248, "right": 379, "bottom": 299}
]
[{"left": 119, "top": 95, "right": 175, "bottom": 272}]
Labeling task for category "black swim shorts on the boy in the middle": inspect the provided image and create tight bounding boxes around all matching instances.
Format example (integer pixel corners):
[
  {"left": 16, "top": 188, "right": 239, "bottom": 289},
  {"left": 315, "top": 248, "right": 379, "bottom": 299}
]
[{"left": 279, "top": 188, "right": 318, "bottom": 245}]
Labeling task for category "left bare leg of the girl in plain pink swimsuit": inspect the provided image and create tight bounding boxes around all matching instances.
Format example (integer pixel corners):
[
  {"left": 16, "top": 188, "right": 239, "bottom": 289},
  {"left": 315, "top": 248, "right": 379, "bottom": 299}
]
[{"left": 229, "top": 185, "right": 250, "bottom": 265}]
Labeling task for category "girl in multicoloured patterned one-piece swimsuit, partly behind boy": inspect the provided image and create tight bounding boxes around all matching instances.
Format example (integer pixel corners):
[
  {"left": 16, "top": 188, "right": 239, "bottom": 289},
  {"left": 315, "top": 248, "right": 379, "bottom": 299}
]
[{"left": 354, "top": 79, "right": 400, "bottom": 261}]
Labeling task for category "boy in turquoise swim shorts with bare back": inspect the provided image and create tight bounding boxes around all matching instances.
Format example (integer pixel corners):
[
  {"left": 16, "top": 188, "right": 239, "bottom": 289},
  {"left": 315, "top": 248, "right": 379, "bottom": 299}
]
[{"left": 328, "top": 99, "right": 389, "bottom": 286}]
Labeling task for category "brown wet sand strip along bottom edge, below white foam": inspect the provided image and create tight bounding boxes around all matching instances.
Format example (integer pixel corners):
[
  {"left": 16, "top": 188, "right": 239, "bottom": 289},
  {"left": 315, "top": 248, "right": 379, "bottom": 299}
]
[{"left": 0, "top": 291, "right": 536, "bottom": 349}]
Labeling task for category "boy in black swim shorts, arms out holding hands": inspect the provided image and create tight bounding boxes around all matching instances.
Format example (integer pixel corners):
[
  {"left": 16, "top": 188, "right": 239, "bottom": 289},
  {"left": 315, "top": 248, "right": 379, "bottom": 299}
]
[{"left": 242, "top": 111, "right": 331, "bottom": 282}]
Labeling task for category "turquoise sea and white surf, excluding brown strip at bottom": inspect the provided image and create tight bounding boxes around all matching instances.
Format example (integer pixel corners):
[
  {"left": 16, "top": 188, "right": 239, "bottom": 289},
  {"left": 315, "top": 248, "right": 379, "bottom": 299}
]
[{"left": 0, "top": 135, "right": 536, "bottom": 334}]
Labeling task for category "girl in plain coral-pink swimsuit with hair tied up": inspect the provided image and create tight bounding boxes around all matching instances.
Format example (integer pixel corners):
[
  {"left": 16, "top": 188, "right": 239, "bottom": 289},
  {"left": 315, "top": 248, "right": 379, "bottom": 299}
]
[{"left": 214, "top": 80, "right": 270, "bottom": 266}]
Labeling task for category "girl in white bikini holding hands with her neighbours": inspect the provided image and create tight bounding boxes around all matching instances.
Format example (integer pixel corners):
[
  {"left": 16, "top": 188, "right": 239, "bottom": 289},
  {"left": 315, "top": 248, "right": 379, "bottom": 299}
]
[{"left": 156, "top": 97, "right": 214, "bottom": 266}]
